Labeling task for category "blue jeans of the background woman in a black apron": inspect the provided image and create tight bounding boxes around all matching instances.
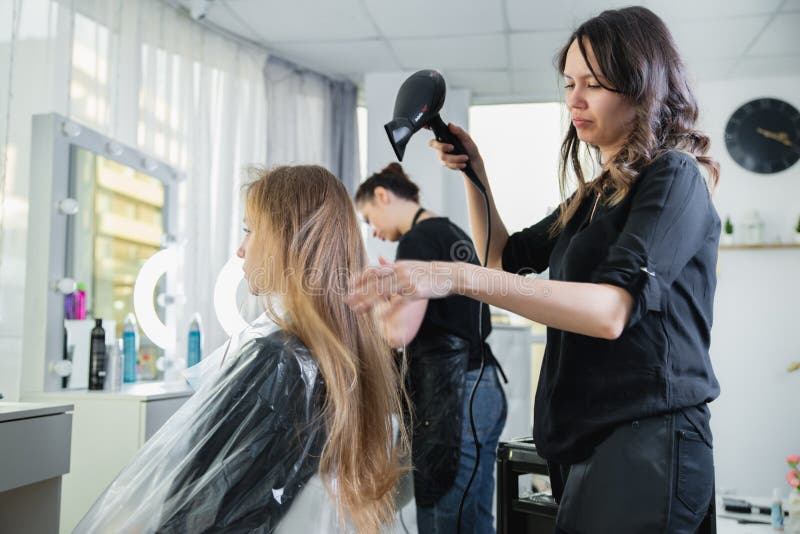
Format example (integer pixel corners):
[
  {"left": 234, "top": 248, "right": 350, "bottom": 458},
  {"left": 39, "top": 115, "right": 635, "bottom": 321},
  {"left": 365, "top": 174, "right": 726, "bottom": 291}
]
[{"left": 417, "top": 366, "right": 508, "bottom": 534}]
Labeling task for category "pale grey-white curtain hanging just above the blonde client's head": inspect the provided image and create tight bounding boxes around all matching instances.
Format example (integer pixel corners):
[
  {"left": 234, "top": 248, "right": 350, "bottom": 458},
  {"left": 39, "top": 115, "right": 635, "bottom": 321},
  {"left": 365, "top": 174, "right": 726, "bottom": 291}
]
[{"left": 264, "top": 56, "right": 360, "bottom": 194}]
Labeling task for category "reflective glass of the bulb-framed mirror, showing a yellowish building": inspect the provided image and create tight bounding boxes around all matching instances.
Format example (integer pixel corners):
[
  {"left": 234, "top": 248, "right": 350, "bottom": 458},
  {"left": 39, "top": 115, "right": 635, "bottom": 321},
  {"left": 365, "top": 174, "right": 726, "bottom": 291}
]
[{"left": 66, "top": 146, "right": 165, "bottom": 380}]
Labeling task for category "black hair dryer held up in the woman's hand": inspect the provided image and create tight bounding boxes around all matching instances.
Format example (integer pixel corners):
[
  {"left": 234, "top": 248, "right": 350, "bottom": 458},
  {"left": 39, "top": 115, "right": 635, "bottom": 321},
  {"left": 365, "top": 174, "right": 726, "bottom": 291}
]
[{"left": 383, "top": 69, "right": 486, "bottom": 193}]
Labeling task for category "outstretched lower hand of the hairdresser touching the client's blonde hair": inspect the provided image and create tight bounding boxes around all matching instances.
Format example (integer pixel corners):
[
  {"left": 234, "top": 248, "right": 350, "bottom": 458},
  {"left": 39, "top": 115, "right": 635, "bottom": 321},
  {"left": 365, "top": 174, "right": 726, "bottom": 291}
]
[{"left": 345, "top": 261, "right": 456, "bottom": 313}]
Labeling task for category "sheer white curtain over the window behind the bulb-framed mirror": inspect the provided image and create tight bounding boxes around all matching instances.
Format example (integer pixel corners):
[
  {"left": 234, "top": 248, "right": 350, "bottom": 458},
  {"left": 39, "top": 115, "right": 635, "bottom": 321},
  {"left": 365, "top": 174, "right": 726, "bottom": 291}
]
[{"left": 0, "top": 0, "right": 267, "bottom": 397}]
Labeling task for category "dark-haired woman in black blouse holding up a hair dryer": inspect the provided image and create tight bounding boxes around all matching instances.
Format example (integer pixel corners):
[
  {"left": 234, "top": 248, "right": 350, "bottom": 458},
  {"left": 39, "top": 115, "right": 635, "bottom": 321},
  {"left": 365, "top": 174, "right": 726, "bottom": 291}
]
[{"left": 349, "top": 7, "right": 720, "bottom": 534}]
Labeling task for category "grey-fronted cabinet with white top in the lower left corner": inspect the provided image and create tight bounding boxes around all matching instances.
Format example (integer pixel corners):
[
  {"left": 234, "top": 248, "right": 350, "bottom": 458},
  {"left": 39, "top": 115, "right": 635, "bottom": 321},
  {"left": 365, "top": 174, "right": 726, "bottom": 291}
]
[{"left": 0, "top": 402, "right": 72, "bottom": 533}]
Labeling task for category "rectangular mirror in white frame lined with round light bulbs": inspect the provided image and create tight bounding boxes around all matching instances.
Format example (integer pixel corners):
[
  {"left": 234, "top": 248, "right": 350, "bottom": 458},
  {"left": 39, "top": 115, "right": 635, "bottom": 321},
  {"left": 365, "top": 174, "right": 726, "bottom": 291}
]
[{"left": 24, "top": 113, "right": 182, "bottom": 391}]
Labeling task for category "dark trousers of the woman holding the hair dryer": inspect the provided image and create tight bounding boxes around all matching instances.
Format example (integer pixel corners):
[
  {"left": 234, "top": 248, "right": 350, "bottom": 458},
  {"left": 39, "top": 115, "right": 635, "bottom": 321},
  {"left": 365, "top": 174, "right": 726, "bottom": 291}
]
[{"left": 548, "top": 412, "right": 714, "bottom": 534}]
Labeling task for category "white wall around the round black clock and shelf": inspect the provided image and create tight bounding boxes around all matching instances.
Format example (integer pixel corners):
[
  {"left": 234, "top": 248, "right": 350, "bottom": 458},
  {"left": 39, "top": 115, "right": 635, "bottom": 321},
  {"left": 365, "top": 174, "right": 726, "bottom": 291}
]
[{"left": 697, "top": 76, "right": 800, "bottom": 495}]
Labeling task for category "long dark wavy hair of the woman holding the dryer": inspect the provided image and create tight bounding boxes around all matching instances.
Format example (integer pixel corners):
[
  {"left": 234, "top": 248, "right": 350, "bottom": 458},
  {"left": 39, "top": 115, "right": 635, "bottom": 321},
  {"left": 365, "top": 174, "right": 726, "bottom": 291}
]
[{"left": 551, "top": 7, "right": 719, "bottom": 233}]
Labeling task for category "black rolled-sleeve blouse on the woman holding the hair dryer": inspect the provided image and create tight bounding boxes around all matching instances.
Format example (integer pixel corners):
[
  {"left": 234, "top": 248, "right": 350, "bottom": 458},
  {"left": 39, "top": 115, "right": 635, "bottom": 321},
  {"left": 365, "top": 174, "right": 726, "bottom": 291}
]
[{"left": 503, "top": 151, "right": 720, "bottom": 464}]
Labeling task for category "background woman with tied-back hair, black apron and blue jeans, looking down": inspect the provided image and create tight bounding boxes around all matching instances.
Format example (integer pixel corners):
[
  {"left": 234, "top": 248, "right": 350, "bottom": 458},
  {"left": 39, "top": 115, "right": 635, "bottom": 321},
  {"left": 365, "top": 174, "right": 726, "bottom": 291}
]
[{"left": 355, "top": 163, "right": 507, "bottom": 533}]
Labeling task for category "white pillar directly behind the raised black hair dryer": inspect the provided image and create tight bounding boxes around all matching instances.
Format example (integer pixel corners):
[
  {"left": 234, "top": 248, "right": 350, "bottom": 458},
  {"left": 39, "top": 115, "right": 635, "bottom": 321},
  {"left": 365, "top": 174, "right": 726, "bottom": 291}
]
[{"left": 364, "top": 72, "right": 470, "bottom": 262}]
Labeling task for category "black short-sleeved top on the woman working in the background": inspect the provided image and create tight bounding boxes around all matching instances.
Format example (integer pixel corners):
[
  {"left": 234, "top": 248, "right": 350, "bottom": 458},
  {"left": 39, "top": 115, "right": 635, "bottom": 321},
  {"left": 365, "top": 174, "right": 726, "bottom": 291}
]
[{"left": 395, "top": 217, "right": 493, "bottom": 369}]
